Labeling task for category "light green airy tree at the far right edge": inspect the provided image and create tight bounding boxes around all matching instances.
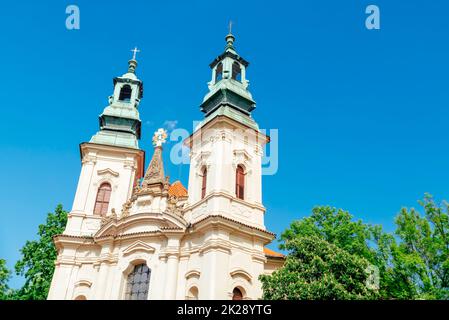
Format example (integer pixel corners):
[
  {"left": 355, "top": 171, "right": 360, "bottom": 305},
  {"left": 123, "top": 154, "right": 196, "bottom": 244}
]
[{"left": 391, "top": 195, "right": 449, "bottom": 299}]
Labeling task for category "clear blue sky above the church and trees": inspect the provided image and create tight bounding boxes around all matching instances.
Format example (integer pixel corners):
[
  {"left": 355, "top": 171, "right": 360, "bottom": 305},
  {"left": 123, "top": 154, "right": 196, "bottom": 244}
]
[{"left": 0, "top": 0, "right": 449, "bottom": 287}]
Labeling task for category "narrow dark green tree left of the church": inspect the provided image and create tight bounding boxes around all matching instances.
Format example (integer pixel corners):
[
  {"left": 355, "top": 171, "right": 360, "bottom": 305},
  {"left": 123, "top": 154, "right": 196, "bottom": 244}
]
[{"left": 15, "top": 205, "right": 67, "bottom": 300}]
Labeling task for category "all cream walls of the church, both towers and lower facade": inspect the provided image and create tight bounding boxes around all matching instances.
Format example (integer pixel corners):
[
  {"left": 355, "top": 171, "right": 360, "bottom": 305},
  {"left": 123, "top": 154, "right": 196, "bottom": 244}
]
[{"left": 48, "top": 117, "right": 275, "bottom": 299}]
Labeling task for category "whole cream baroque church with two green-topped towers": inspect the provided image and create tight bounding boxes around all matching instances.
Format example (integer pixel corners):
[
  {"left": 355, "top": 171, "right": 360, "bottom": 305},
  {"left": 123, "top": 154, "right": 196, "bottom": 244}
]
[{"left": 48, "top": 32, "right": 285, "bottom": 300}]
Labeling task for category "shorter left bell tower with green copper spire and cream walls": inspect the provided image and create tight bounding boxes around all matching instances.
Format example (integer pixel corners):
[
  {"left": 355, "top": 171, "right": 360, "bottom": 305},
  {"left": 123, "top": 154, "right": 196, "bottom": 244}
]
[{"left": 64, "top": 49, "right": 145, "bottom": 236}]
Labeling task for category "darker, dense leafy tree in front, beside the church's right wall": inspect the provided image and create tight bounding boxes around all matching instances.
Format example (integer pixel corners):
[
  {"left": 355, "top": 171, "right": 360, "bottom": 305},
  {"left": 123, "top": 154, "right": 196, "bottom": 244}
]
[{"left": 260, "top": 236, "right": 377, "bottom": 300}]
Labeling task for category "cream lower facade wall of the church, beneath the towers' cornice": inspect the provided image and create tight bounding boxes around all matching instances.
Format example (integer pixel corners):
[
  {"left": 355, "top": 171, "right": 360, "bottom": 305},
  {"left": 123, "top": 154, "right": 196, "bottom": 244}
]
[{"left": 48, "top": 229, "right": 272, "bottom": 300}]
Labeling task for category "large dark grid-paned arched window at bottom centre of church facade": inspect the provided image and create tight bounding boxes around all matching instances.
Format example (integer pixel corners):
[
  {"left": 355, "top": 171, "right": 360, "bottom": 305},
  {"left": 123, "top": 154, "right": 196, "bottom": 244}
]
[{"left": 126, "top": 263, "right": 151, "bottom": 300}]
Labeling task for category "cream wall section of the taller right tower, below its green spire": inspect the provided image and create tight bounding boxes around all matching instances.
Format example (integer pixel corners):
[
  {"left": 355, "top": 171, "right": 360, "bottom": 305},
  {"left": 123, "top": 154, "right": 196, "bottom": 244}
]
[{"left": 184, "top": 120, "right": 265, "bottom": 229}]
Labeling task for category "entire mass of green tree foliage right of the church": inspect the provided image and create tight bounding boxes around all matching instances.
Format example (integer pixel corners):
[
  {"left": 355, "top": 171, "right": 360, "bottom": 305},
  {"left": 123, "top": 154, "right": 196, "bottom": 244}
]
[{"left": 261, "top": 195, "right": 449, "bottom": 299}]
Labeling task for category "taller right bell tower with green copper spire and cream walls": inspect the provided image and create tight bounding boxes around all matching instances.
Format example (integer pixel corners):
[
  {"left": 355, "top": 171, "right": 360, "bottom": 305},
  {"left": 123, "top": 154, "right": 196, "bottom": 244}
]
[{"left": 185, "top": 30, "right": 269, "bottom": 229}]
